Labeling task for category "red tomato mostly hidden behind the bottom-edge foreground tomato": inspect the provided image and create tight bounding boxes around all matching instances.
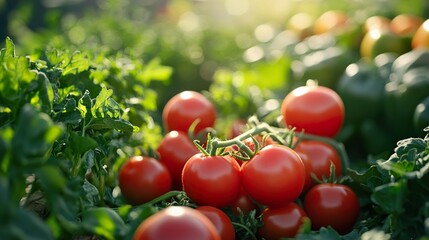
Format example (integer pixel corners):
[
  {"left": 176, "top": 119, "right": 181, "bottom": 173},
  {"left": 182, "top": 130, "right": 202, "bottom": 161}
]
[{"left": 196, "top": 206, "right": 235, "bottom": 240}]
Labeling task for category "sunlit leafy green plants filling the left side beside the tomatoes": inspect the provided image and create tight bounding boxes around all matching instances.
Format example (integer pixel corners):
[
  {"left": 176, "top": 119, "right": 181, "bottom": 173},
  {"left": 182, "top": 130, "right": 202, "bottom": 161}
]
[{"left": 0, "top": 38, "right": 171, "bottom": 239}]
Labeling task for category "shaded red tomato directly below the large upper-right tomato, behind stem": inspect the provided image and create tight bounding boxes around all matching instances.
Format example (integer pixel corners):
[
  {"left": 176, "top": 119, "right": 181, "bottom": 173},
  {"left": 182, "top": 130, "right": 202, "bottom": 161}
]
[{"left": 294, "top": 140, "right": 342, "bottom": 190}]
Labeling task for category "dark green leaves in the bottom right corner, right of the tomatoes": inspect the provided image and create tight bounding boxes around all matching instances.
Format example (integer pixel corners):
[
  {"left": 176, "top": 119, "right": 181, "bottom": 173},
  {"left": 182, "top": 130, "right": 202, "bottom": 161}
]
[{"left": 349, "top": 129, "right": 429, "bottom": 239}]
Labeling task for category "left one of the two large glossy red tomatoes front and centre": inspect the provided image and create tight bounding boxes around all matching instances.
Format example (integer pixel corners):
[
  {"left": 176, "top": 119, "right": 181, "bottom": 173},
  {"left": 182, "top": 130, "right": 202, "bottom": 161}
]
[{"left": 182, "top": 153, "right": 241, "bottom": 208}]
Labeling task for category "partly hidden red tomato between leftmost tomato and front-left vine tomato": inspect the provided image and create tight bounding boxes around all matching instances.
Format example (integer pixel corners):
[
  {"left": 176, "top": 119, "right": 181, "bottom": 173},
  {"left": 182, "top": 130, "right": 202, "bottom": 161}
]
[{"left": 157, "top": 131, "right": 199, "bottom": 190}]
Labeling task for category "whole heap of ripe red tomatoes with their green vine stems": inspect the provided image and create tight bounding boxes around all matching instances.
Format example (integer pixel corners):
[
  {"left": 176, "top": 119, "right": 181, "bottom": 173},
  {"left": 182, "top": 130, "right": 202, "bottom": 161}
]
[{"left": 119, "top": 85, "right": 360, "bottom": 239}]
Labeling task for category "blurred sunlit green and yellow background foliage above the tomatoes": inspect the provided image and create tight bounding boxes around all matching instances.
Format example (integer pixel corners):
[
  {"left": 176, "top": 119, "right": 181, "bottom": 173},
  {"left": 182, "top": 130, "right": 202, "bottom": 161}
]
[{"left": 0, "top": 0, "right": 429, "bottom": 159}]
